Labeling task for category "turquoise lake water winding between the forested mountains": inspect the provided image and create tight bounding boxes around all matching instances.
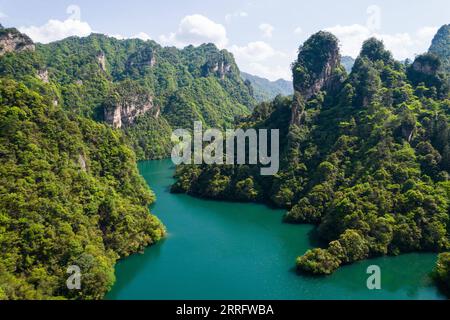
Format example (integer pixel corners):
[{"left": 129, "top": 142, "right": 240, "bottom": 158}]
[{"left": 106, "top": 160, "right": 444, "bottom": 299}]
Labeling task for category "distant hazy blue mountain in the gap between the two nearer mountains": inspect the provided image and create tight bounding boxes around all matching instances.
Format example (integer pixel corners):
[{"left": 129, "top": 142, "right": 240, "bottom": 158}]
[{"left": 241, "top": 72, "right": 294, "bottom": 102}]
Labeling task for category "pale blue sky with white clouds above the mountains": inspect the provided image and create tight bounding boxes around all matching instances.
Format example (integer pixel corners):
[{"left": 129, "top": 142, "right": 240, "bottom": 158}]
[{"left": 0, "top": 0, "right": 450, "bottom": 80}]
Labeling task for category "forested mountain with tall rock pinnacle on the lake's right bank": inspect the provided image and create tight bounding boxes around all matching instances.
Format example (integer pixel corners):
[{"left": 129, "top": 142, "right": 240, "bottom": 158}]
[{"left": 173, "top": 32, "right": 450, "bottom": 284}]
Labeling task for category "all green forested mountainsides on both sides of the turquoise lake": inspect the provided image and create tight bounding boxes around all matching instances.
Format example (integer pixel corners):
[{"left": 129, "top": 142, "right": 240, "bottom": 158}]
[{"left": 0, "top": 19, "right": 450, "bottom": 300}]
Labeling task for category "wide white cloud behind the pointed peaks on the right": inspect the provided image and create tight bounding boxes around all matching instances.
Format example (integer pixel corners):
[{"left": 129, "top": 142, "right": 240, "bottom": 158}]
[{"left": 325, "top": 24, "right": 437, "bottom": 60}]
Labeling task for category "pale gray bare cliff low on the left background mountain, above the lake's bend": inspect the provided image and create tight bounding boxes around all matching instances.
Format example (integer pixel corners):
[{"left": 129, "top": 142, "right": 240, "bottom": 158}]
[{"left": 104, "top": 95, "right": 160, "bottom": 128}]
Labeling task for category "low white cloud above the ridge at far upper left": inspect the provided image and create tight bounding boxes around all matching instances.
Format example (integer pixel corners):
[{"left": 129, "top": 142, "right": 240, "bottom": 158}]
[{"left": 19, "top": 18, "right": 92, "bottom": 43}]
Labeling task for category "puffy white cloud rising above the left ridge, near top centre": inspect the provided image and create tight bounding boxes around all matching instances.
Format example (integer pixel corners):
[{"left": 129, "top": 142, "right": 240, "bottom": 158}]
[{"left": 159, "top": 14, "right": 228, "bottom": 48}]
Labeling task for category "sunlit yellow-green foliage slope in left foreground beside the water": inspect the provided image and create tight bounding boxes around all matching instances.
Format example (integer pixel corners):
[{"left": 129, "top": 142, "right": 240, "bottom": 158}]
[{"left": 0, "top": 79, "right": 164, "bottom": 299}]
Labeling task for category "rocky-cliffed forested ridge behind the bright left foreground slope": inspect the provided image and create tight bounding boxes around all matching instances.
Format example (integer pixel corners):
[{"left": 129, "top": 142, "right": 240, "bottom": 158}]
[{"left": 0, "top": 29, "right": 255, "bottom": 159}]
